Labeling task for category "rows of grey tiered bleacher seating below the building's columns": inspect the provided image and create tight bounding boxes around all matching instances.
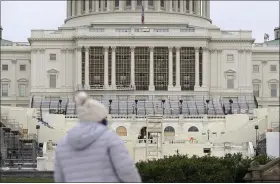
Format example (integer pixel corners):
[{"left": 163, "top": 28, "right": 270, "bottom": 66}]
[{"left": 32, "top": 96, "right": 256, "bottom": 116}]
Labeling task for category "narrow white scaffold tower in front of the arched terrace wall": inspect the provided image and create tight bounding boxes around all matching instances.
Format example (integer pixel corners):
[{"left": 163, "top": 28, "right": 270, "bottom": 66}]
[{"left": 146, "top": 115, "right": 163, "bottom": 159}]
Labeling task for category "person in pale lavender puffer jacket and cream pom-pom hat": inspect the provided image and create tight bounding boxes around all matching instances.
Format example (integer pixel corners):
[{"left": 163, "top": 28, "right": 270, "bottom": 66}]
[{"left": 54, "top": 92, "right": 141, "bottom": 183}]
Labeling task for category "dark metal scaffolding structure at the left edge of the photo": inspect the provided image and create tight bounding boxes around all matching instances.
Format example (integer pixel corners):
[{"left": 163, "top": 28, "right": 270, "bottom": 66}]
[{"left": 0, "top": 115, "right": 38, "bottom": 169}]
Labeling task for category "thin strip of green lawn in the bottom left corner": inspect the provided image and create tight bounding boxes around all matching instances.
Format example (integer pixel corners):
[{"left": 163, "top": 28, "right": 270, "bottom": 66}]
[{"left": 1, "top": 178, "right": 54, "bottom": 183}]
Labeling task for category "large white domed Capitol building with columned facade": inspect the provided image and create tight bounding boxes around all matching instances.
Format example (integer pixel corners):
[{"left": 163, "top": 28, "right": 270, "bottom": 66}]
[{"left": 1, "top": 0, "right": 280, "bottom": 164}]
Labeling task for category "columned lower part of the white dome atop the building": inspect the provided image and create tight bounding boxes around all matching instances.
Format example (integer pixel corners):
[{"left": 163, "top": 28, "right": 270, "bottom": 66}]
[{"left": 63, "top": 0, "right": 211, "bottom": 27}]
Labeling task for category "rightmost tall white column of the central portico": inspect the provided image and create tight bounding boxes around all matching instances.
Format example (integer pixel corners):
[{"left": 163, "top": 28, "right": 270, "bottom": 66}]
[{"left": 202, "top": 47, "right": 210, "bottom": 88}]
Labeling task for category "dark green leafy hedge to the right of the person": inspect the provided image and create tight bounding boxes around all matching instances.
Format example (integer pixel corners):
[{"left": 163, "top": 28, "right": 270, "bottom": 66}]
[{"left": 136, "top": 154, "right": 271, "bottom": 183}]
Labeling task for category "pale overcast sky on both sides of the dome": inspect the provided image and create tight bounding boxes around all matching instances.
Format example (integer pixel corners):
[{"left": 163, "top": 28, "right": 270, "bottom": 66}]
[{"left": 0, "top": 0, "right": 279, "bottom": 42}]
